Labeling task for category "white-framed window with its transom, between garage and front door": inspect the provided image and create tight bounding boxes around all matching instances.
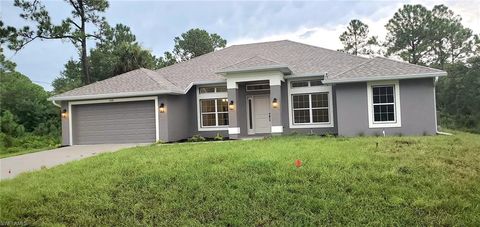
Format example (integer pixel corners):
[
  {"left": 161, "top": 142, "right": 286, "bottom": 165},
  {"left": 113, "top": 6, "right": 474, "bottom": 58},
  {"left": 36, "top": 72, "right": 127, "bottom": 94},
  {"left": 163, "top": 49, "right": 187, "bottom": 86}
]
[{"left": 197, "top": 86, "right": 228, "bottom": 130}]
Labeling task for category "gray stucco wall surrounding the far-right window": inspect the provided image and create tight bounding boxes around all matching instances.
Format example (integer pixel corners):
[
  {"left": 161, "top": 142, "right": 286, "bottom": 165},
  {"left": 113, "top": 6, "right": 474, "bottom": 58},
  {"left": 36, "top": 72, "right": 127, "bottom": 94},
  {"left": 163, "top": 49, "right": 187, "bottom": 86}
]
[{"left": 335, "top": 78, "right": 436, "bottom": 136}]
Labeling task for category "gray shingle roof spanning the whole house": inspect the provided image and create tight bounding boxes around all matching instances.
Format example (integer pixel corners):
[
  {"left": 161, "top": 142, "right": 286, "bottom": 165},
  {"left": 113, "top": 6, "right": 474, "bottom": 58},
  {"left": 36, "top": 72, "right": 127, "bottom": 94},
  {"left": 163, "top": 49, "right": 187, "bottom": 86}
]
[{"left": 52, "top": 40, "right": 443, "bottom": 100}]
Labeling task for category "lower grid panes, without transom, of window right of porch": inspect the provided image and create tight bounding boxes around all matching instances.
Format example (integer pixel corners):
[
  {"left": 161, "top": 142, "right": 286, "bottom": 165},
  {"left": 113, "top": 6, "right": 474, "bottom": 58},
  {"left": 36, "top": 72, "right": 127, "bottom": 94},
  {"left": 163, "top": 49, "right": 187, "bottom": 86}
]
[{"left": 292, "top": 93, "right": 329, "bottom": 124}]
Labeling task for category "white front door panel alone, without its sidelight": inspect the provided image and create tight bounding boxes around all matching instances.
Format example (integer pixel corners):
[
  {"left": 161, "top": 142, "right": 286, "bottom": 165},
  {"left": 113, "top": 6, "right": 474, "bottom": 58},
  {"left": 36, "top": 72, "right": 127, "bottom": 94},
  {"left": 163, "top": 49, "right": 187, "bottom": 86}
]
[{"left": 253, "top": 95, "right": 272, "bottom": 133}]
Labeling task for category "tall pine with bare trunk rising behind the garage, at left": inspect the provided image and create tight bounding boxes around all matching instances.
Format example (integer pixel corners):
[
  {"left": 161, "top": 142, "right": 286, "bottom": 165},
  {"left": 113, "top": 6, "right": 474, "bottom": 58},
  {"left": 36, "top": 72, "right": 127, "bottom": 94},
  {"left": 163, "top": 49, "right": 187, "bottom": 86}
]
[{"left": 11, "top": 0, "right": 108, "bottom": 84}]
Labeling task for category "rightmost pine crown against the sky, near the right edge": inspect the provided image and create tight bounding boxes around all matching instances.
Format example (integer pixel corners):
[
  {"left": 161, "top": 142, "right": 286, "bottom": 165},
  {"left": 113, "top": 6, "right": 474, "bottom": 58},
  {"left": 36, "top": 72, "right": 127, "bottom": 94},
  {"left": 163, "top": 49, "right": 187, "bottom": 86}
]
[{"left": 429, "top": 5, "right": 475, "bottom": 69}]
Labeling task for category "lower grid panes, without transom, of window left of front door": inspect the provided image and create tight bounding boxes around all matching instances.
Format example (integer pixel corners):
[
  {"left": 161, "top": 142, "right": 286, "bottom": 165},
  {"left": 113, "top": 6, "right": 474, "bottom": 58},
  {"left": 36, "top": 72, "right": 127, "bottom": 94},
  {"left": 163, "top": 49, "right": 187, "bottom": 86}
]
[{"left": 200, "top": 99, "right": 228, "bottom": 127}]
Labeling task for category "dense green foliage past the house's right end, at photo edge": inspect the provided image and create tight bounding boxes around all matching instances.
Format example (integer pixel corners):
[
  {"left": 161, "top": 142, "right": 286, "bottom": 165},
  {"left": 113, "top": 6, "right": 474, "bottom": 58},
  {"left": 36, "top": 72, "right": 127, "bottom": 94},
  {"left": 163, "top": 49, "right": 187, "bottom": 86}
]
[{"left": 436, "top": 57, "right": 480, "bottom": 133}]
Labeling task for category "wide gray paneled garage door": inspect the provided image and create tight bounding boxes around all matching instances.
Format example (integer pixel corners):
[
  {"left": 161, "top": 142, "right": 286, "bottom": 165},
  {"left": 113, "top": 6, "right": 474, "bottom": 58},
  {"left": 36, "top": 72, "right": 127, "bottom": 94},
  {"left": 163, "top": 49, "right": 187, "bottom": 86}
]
[{"left": 72, "top": 100, "right": 155, "bottom": 144}]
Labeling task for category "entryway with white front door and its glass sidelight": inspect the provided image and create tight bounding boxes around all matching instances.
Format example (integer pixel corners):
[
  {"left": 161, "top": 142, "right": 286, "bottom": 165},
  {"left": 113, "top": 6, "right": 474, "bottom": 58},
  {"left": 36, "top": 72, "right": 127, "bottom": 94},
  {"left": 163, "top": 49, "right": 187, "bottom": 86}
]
[{"left": 247, "top": 95, "right": 272, "bottom": 135}]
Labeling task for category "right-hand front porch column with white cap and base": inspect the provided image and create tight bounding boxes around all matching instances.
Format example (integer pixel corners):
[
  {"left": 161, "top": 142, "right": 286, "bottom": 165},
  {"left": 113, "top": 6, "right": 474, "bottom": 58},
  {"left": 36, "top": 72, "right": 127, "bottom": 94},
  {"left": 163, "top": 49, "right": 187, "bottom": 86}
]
[{"left": 270, "top": 80, "right": 283, "bottom": 135}]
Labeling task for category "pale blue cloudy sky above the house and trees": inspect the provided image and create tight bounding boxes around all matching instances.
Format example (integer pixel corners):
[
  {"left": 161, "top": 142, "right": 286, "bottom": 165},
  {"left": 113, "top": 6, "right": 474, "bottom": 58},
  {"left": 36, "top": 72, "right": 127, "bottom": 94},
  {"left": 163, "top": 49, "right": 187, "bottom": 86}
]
[{"left": 0, "top": 0, "right": 480, "bottom": 90}]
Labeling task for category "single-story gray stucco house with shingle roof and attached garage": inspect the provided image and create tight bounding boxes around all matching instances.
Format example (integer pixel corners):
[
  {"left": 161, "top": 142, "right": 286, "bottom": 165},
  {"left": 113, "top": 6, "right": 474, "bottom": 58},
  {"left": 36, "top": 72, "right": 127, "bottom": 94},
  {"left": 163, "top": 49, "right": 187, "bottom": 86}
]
[{"left": 50, "top": 40, "right": 446, "bottom": 145}]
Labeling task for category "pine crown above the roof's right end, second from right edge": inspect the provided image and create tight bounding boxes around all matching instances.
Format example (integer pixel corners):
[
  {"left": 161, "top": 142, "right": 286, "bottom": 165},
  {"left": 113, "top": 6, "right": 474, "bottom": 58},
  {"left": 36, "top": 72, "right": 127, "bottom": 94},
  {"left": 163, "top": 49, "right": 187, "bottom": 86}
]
[{"left": 385, "top": 5, "right": 431, "bottom": 64}]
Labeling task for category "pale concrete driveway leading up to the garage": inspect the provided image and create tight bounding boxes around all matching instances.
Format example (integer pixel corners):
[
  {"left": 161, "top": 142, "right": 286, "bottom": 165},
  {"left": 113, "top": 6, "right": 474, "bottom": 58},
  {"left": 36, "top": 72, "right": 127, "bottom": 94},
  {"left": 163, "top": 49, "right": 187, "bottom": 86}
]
[{"left": 0, "top": 144, "right": 141, "bottom": 180}]
